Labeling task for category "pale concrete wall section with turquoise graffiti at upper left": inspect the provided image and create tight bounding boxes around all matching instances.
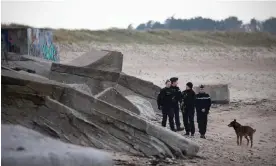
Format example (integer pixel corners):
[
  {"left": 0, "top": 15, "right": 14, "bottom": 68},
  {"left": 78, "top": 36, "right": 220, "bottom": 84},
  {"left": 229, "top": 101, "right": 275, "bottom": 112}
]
[{"left": 28, "top": 28, "right": 59, "bottom": 62}]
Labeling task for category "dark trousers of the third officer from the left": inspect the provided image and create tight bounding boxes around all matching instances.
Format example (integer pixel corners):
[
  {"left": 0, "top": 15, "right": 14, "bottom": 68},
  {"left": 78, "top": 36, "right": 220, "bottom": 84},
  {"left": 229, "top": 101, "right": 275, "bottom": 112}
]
[{"left": 183, "top": 108, "right": 195, "bottom": 134}]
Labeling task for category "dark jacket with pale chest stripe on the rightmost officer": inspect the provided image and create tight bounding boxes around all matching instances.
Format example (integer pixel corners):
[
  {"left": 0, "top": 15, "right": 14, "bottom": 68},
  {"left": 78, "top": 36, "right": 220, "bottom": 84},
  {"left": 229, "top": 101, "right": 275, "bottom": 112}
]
[{"left": 196, "top": 93, "right": 211, "bottom": 114}]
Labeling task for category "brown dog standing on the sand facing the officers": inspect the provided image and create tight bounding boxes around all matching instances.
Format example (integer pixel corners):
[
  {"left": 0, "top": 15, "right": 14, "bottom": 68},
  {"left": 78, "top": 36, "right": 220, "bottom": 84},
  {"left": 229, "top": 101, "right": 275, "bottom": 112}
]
[{"left": 228, "top": 119, "right": 256, "bottom": 148}]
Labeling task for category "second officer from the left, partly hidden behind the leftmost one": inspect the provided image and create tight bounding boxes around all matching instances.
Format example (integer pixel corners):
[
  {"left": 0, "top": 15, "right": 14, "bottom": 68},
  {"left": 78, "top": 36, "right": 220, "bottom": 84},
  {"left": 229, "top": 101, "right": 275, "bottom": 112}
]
[{"left": 170, "top": 77, "right": 184, "bottom": 131}]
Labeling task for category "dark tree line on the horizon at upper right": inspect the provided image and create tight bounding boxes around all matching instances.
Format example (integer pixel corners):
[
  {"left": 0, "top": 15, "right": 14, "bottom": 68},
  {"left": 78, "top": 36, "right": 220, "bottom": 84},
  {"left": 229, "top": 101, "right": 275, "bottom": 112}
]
[{"left": 136, "top": 16, "right": 276, "bottom": 34}]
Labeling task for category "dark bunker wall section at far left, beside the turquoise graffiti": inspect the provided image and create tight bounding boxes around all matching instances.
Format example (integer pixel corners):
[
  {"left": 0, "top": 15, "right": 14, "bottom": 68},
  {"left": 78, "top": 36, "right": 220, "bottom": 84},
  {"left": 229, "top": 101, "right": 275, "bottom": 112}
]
[{"left": 1, "top": 29, "right": 28, "bottom": 54}]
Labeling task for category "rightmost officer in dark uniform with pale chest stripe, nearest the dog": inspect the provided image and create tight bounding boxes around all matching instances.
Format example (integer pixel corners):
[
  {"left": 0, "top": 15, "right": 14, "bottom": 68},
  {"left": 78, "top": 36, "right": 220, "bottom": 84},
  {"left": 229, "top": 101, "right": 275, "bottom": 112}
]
[{"left": 196, "top": 85, "right": 211, "bottom": 139}]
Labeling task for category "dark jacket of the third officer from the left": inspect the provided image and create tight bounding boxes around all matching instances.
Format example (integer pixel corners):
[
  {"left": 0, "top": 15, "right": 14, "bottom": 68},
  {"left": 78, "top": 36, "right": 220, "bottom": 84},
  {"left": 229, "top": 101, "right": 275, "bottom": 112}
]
[{"left": 181, "top": 89, "right": 196, "bottom": 109}]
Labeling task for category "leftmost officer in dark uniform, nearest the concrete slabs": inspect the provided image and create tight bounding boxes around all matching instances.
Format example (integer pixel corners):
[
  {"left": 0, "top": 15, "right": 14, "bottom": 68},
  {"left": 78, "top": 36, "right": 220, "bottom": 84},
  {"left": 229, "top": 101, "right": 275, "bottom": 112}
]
[{"left": 157, "top": 80, "right": 175, "bottom": 131}]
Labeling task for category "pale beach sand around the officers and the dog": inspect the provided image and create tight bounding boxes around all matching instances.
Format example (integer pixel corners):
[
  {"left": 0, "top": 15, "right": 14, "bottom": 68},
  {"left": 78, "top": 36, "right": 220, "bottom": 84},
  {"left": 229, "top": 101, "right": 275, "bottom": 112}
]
[{"left": 59, "top": 43, "right": 276, "bottom": 166}]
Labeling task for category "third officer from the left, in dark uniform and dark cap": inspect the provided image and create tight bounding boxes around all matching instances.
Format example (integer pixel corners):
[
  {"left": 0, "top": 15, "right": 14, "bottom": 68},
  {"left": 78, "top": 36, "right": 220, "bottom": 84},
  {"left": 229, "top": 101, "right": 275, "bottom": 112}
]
[{"left": 181, "top": 82, "right": 196, "bottom": 136}]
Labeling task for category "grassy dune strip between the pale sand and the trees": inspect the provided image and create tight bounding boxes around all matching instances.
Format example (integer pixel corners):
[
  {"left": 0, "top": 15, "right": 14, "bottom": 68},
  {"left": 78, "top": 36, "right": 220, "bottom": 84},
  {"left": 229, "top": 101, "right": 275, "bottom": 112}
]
[{"left": 54, "top": 29, "right": 276, "bottom": 47}]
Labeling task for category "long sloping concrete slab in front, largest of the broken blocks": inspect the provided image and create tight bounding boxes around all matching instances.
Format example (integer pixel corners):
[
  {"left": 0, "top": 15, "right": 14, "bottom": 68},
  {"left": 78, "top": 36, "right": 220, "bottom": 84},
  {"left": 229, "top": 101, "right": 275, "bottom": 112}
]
[{"left": 1, "top": 70, "right": 199, "bottom": 158}]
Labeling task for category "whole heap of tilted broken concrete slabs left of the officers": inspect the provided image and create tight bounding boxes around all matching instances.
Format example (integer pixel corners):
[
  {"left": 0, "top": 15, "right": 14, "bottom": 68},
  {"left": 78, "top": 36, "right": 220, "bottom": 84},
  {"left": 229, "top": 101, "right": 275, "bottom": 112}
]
[{"left": 1, "top": 50, "right": 203, "bottom": 165}]
